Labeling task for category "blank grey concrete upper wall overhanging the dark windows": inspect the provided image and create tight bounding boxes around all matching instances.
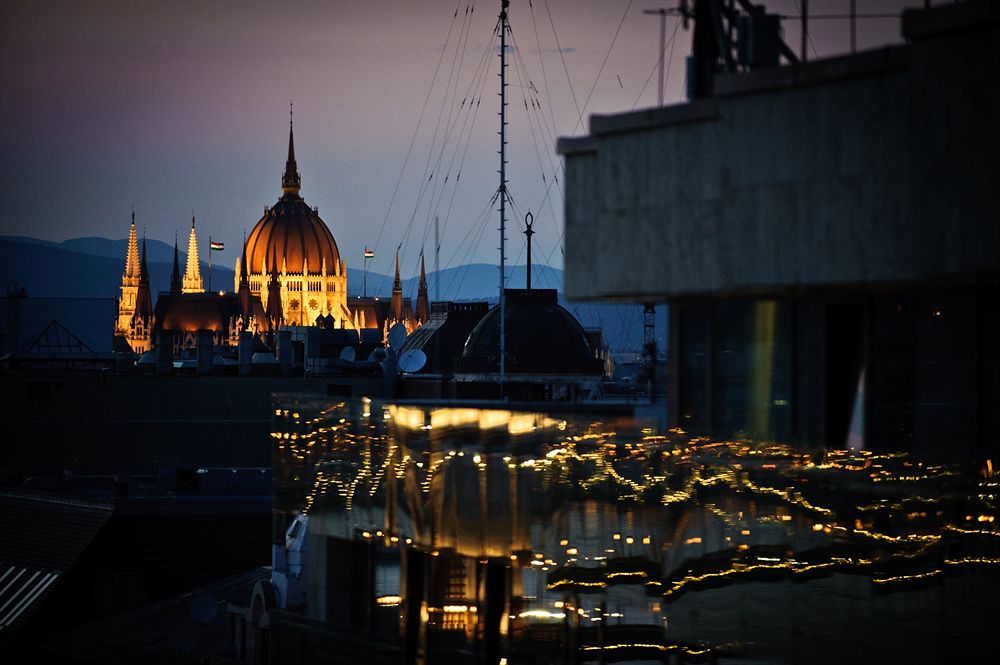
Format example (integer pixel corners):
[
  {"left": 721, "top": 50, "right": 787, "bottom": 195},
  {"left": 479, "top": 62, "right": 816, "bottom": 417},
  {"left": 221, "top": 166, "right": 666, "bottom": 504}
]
[{"left": 558, "top": 2, "right": 1000, "bottom": 301}]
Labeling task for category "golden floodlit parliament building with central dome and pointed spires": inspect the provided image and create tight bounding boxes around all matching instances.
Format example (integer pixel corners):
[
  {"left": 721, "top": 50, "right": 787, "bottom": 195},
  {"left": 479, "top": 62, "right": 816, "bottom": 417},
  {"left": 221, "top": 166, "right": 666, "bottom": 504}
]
[{"left": 115, "top": 123, "right": 430, "bottom": 354}]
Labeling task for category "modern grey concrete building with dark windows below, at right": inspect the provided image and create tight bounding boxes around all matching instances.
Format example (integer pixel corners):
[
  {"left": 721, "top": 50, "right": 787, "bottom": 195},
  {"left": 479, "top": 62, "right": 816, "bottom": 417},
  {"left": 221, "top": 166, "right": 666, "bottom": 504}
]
[{"left": 558, "top": 1, "right": 1000, "bottom": 460}]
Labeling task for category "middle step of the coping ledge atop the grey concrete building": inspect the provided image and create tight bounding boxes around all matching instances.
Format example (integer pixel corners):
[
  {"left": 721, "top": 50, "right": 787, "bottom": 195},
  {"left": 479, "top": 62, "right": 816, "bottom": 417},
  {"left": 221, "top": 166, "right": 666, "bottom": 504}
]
[{"left": 715, "top": 45, "right": 910, "bottom": 97}]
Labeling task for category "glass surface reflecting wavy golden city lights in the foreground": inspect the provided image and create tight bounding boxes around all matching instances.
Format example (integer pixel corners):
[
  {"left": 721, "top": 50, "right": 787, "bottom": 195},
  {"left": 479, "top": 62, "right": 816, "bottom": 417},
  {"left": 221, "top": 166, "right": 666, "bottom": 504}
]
[{"left": 273, "top": 398, "right": 1000, "bottom": 663}]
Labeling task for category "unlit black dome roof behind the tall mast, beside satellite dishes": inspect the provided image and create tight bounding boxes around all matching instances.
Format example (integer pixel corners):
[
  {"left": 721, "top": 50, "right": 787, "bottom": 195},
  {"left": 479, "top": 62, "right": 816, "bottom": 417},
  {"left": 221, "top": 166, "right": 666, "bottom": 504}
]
[{"left": 460, "top": 289, "right": 601, "bottom": 373}]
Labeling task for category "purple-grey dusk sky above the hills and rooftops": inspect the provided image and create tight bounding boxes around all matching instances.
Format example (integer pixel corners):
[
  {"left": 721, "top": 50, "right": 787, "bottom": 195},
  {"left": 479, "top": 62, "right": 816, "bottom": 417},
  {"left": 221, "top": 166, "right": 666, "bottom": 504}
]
[{"left": 0, "top": 0, "right": 922, "bottom": 276}]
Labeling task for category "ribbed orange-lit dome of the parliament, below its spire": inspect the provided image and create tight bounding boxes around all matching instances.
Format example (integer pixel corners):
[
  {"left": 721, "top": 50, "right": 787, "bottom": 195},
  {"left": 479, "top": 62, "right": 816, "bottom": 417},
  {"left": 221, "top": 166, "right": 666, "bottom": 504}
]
[{"left": 246, "top": 193, "right": 340, "bottom": 274}]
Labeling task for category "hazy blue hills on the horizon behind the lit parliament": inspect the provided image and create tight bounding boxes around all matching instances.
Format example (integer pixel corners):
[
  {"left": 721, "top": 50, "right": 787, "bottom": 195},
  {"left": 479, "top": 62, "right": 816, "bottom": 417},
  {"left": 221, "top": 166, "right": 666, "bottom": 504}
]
[{"left": 0, "top": 236, "right": 643, "bottom": 351}]
